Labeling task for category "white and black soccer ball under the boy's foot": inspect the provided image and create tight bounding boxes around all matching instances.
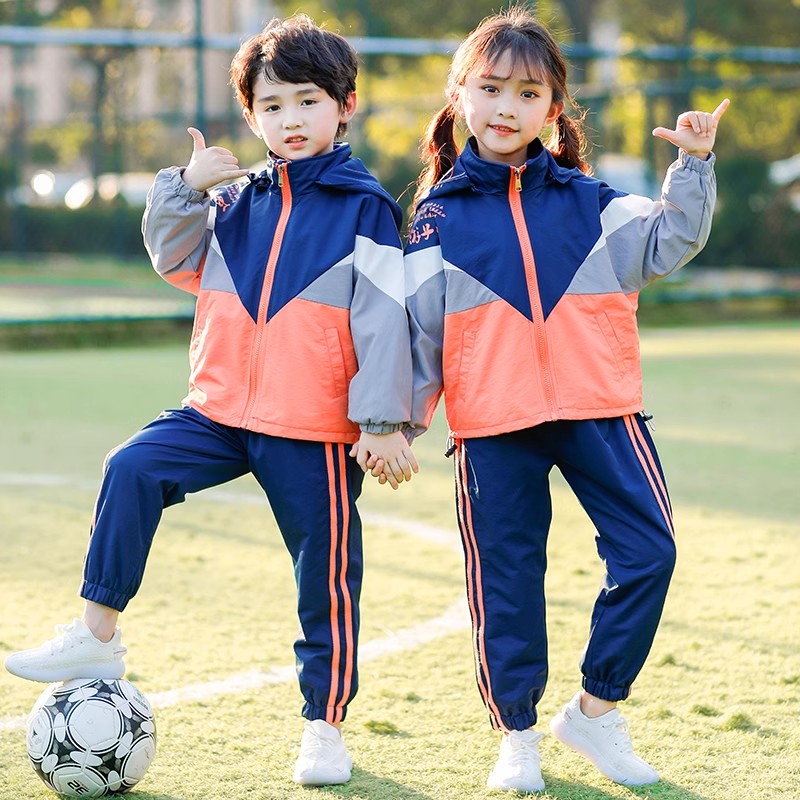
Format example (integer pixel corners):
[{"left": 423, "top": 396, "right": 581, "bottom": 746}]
[{"left": 27, "top": 679, "right": 156, "bottom": 797}]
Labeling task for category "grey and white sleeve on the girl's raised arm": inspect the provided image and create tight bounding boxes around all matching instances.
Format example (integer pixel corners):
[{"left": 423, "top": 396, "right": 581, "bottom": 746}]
[{"left": 601, "top": 151, "right": 717, "bottom": 292}]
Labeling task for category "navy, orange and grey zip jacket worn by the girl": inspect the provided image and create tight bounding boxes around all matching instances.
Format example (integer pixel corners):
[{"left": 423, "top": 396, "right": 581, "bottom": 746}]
[{"left": 405, "top": 140, "right": 716, "bottom": 438}]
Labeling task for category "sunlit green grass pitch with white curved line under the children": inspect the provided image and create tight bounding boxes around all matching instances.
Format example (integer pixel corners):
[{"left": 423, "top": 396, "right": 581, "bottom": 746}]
[{"left": 0, "top": 324, "right": 800, "bottom": 800}]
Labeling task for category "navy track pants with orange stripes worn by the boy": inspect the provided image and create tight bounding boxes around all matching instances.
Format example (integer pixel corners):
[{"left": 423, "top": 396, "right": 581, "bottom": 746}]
[{"left": 80, "top": 408, "right": 363, "bottom": 723}]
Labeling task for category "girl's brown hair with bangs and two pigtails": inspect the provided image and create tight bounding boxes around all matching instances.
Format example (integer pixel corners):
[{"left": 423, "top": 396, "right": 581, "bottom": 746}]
[{"left": 413, "top": 6, "right": 591, "bottom": 208}]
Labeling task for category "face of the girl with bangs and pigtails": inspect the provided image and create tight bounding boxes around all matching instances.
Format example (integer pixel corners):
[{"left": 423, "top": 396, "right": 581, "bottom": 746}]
[{"left": 456, "top": 54, "right": 564, "bottom": 167}]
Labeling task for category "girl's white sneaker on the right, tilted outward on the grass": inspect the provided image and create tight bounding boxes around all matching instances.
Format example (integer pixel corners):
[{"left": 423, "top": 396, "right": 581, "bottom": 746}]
[{"left": 550, "top": 692, "right": 658, "bottom": 786}]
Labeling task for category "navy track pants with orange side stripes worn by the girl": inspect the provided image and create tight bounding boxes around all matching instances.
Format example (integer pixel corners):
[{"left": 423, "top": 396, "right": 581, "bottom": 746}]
[{"left": 455, "top": 415, "right": 675, "bottom": 730}]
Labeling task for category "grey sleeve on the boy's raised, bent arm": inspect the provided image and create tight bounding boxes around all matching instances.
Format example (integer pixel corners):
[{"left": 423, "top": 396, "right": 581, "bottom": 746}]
[{"left": 142, "top": 167, "right": 214, "bottom": 294}]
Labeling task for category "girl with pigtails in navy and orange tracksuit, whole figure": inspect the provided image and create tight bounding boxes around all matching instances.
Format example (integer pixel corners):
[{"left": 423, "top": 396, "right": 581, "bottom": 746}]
[{"left": 406, "top": 8, "right": 728, "bottom": 791}]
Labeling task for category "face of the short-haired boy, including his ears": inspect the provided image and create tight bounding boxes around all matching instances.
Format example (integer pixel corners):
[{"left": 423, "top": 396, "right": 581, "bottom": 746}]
[{"left": 244, "top": 75, "right": 356, "bottom": 161}]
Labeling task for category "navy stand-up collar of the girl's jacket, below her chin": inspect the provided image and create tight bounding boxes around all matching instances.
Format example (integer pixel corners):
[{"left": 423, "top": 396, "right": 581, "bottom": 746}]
[{"left": 428, "top": 137, "right": 580, "bottom": 197}]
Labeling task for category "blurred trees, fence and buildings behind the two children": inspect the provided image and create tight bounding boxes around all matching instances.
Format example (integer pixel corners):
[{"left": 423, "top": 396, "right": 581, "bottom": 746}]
[{"left": 0, "top": 0, "right": 800, "bottom": 340}]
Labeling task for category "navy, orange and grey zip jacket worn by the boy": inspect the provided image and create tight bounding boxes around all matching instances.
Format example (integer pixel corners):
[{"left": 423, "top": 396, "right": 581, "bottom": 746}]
[{"left": 142, "top": 144, "right": 411, "bottom": 442}]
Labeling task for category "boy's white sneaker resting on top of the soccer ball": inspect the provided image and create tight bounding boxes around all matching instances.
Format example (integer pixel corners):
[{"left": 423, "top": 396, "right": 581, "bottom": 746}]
[{"left": 5, "top": 619, "right": 128, "bottom": 683}]
